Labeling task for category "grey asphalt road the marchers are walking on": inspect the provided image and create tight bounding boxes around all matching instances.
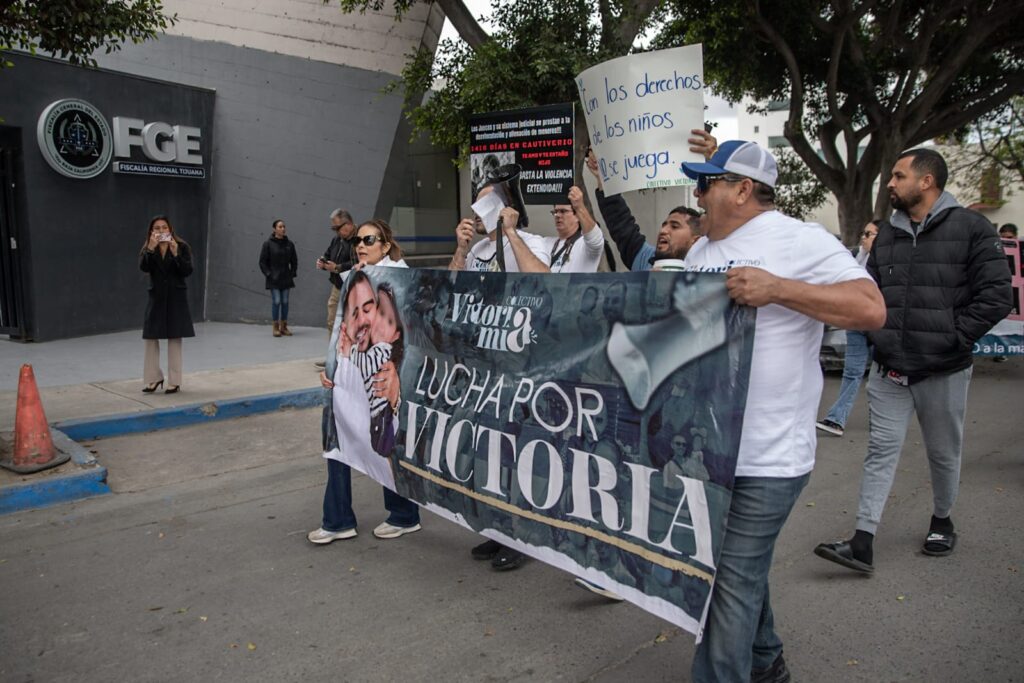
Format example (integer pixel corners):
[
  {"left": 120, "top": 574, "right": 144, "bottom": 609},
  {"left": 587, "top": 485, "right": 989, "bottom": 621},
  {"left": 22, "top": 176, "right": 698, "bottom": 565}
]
[{"left": 0, "top": 358, "right": 1024, "bottom": 681}]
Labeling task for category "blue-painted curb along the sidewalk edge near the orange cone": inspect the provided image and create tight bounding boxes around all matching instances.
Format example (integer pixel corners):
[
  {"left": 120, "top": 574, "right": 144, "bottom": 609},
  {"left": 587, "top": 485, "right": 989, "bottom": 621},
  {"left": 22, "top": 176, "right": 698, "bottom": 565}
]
[{"left": 0, "top": 387, "right": 324, "bottom": 515}]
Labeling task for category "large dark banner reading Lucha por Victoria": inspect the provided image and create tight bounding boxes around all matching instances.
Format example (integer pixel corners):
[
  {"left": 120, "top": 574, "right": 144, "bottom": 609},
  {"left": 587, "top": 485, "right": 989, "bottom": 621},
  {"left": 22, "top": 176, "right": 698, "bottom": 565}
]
[{"left": 324, "top": 267, "right": 756, "bottom": 633}]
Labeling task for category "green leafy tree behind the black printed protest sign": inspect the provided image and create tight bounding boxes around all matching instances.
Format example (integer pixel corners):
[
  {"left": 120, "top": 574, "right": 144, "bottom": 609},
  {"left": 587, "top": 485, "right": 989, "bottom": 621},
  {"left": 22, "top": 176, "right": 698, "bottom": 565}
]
[{"left": 335, "top": 0, "right": 663, "bottom": 192}]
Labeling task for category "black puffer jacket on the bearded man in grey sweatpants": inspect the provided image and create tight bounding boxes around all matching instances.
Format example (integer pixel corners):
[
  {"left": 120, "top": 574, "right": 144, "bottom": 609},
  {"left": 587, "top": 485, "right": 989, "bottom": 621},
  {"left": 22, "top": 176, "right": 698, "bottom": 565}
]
[{"left": 867, "top": 193, "right": 1012, "bottom": 379}]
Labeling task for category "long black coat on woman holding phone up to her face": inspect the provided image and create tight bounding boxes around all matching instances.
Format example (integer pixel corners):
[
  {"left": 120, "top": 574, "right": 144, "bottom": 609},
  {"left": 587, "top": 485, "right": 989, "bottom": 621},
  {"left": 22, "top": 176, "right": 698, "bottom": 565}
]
[{"left": 138, "top": 242, "right": 196, "bottom": 339}]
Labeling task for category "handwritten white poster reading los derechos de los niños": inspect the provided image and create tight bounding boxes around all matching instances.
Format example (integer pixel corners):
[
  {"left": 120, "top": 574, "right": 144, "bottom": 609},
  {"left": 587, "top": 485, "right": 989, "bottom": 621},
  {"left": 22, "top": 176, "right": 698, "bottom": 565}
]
[{"left": 577, "top": 45, "right": 703, "bottom": 196}]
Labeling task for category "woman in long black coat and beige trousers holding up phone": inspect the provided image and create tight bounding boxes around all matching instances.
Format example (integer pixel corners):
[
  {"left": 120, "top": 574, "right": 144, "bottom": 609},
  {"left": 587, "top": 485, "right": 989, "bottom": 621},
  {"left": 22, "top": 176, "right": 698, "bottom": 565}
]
[{"left": 138, "top": 216, "right": 196, "bottom": 393}]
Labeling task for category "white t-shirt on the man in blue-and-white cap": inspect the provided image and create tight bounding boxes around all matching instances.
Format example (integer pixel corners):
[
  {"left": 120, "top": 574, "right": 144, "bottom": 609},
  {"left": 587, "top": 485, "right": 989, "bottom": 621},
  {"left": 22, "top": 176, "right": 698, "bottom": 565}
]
[{"left": 686, "top": 211, "right": 870, "bottom": 477}]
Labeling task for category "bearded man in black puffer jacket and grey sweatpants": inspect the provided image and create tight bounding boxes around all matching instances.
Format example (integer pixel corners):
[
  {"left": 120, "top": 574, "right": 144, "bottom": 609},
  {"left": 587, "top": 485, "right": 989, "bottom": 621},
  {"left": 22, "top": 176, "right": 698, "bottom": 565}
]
[{"left": 814, "top": 148, "right": 1011, "bottom": 572}]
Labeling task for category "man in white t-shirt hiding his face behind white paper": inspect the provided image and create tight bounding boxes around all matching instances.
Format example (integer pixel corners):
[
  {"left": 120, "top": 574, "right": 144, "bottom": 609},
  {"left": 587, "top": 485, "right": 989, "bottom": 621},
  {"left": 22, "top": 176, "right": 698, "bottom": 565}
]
[{"left": 449, "top": 185, "right": 551, "bottom": 272}]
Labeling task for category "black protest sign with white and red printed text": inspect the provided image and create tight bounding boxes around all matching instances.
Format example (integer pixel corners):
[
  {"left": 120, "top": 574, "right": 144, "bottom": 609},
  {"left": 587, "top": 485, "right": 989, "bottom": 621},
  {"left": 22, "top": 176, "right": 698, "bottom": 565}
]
[{"left": 469, "top": 102, "right": 575, "bottom": 204}]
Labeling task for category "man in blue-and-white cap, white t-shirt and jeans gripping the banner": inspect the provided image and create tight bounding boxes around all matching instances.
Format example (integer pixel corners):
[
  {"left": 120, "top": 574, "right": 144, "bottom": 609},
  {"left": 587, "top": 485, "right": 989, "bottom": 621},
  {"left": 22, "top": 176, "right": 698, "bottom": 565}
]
[{"left": 683, "top": 140, "right": 886, "bottom": 682}]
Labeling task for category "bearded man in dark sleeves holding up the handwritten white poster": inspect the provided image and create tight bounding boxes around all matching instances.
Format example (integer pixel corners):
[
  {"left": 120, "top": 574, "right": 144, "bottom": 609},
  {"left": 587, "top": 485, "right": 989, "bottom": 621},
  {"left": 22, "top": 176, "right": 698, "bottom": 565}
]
[{"left": 587, "top": 129, "right": 718, "bottom": 270}]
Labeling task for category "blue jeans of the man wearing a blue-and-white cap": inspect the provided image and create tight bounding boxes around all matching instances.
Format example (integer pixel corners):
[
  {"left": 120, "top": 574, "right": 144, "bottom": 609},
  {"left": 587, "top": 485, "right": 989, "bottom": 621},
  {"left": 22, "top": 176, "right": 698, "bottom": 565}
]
[{"left": 690, "top": 474, "right": 811, "bottom": 683}]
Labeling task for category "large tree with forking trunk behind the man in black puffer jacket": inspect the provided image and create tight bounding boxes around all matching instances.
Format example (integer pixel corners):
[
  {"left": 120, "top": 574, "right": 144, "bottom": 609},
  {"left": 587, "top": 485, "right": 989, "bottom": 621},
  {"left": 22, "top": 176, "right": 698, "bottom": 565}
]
[{"left": 655, "top": 0, "right": 1024, "bottom": 245}]
